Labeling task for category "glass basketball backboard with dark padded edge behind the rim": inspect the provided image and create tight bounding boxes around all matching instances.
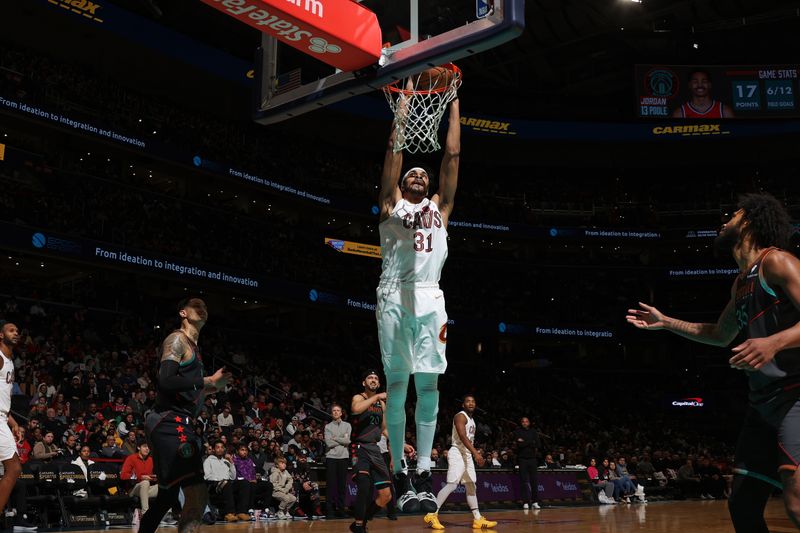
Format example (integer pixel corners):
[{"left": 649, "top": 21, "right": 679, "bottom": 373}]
[{"left": 250, "top": 0, "right": 525, "bottom": 124}]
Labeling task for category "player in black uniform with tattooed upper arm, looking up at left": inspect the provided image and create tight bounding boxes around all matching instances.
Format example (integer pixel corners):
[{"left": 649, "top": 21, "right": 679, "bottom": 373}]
[{"left": 139, "top": 298, "right": 230, "bottom": 533}]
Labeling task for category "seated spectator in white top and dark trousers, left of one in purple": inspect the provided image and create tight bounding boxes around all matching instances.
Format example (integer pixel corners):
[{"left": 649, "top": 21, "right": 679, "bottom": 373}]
[{"left": 203, "top": 441, "right": 250, "bottom": 522}]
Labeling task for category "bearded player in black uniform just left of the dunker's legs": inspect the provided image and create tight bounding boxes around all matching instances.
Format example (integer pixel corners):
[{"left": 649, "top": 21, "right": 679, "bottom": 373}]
[{"left": 350, "top": 370, "right": 392, "bottom": 533}]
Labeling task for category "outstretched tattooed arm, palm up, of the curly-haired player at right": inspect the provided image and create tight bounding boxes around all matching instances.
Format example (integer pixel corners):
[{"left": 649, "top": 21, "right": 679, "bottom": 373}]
[{"left": 625, "top": 289, "right": 739, "bottom": 346}]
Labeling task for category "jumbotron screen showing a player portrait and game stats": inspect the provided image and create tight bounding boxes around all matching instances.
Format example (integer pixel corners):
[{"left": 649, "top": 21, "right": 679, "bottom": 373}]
[{"left": 636, "top": 65, "right": 800, "bottom": 119}]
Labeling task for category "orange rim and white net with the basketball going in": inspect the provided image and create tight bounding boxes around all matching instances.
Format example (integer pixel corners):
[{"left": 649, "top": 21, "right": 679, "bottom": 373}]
[{"left": 383, "top": 63, "right": 461, "bottom": 154}]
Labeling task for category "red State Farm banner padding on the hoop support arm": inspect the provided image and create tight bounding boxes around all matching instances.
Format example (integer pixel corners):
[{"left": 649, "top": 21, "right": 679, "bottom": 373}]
[{"left": 203, "top": 0, "right": 383, "bottom": 71}]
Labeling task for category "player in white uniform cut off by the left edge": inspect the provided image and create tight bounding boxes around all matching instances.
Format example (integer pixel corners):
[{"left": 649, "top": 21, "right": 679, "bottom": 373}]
[{"left": 0, "top": 322, "right": 36, "bottom": 531}]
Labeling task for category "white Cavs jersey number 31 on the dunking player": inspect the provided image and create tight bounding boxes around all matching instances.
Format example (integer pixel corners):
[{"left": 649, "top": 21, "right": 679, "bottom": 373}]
[{"left": 378, "top": 198, "right": 447, "bottom": 283}]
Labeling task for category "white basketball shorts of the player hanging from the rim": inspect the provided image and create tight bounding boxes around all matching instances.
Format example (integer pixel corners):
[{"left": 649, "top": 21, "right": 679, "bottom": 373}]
[{"left": 375, "top": 282, "right": 447, "bottom": 374}]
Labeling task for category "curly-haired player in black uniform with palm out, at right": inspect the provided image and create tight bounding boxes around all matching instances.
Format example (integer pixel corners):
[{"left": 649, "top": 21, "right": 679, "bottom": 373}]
[{"left": 626, "top": 194, "right": 800, "bottom": 533}]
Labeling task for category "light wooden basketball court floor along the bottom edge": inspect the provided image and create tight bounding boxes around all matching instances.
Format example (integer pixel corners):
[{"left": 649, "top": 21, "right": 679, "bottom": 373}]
[{"left": 57, "top": 498, "right": 797, "bottom": 533}]
